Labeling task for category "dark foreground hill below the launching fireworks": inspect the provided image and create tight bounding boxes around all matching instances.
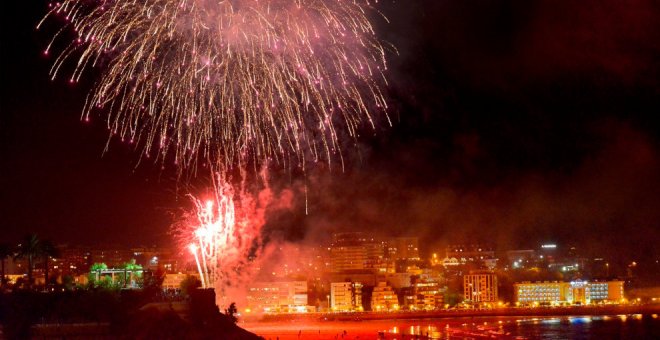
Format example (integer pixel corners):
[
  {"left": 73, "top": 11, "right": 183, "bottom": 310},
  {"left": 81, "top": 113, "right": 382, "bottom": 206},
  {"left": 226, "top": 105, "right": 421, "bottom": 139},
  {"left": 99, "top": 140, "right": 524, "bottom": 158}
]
[{"left": 0, "top": 290, "right": 261, "bottom": 340}]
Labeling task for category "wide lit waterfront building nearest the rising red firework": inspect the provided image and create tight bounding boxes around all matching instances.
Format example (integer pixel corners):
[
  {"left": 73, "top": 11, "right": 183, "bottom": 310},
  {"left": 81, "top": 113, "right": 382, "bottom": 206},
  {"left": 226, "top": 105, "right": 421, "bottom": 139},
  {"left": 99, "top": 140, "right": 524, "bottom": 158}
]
[{"left": 247, "top": 281, "right": 308, "bottom": 313}]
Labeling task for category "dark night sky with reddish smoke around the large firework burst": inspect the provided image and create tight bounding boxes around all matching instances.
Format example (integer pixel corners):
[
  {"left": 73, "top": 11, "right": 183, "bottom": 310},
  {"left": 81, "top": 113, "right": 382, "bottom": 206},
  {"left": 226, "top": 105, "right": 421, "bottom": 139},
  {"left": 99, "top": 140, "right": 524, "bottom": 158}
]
[{"left": 0, "top": 0, "right": 660, "bottom": 256}]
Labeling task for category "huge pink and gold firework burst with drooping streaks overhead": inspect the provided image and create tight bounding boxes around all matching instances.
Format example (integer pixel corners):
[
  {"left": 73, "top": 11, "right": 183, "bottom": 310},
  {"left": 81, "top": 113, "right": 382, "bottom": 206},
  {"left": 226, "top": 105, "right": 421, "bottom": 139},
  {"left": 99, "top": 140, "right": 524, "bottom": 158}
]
[{"left": 40, "top": 0, "right": 387, "bottom": 174}]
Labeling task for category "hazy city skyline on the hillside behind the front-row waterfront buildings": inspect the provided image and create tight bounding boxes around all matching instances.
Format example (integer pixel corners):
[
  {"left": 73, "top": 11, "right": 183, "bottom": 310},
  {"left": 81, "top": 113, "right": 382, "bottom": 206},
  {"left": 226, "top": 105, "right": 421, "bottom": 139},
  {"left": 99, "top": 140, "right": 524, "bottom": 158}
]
[{"left": 1, "top": 232, "right": 648, "bottom": 285}]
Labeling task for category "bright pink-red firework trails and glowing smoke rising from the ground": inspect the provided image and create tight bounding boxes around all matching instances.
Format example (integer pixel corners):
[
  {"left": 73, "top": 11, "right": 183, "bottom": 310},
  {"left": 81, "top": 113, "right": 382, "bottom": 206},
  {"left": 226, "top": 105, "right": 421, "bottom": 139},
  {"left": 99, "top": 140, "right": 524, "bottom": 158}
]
[{"left": 173, "top": 175, "right": 292, "bottom": 301}]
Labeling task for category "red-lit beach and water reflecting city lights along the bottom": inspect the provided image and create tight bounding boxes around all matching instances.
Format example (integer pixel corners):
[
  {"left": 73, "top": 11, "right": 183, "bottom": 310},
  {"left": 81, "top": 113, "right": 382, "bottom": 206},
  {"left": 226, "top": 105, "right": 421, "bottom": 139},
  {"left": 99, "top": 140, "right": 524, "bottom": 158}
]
[{"left": 244, "top": 309, "right": 660, "bottom": 340}]
